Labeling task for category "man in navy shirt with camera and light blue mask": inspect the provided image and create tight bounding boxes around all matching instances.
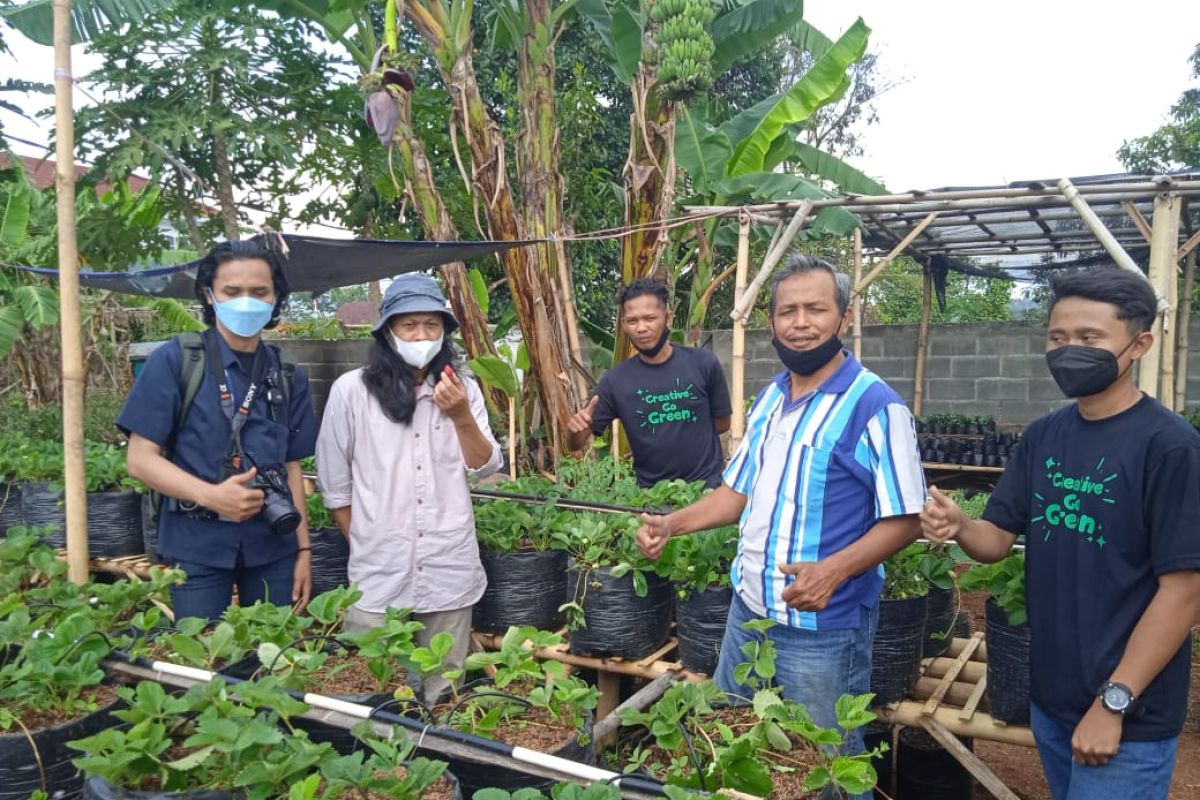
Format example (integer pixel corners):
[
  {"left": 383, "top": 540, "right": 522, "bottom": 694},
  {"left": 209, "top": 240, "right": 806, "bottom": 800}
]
[{"left": 116, "top": 240, "right": 317, "bottom": 619}]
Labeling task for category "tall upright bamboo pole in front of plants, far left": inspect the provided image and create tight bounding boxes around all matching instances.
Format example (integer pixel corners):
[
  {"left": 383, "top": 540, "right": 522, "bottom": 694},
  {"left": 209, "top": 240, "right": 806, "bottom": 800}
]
[{"left": 54, "top": 0, "right": 88, "bottom": 583}]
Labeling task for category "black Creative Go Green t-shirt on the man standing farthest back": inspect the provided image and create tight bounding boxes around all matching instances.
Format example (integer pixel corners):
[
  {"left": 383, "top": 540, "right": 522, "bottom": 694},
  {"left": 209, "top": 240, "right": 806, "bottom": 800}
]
[{"left": 592, "top": 344, "right": 732, "bottom": 488}]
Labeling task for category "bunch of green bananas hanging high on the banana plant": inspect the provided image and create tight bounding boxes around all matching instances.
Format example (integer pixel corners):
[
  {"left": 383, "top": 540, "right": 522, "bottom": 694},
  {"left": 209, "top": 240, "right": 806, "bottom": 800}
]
[{"left": 650, "top": 0, "right": 715, "bottom": 100}]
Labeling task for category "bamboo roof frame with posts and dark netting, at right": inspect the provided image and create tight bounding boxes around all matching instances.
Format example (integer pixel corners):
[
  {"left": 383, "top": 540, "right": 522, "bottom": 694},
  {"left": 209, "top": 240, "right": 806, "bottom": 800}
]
[{"left": 684, "top": 167, "right": 1200, "bottom": 412}]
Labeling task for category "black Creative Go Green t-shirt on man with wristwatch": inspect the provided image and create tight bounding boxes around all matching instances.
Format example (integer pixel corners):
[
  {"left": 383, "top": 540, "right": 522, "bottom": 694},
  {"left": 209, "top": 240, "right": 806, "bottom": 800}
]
[{"left": 983, "top": 397, "right": 1200, "bottom": 741}]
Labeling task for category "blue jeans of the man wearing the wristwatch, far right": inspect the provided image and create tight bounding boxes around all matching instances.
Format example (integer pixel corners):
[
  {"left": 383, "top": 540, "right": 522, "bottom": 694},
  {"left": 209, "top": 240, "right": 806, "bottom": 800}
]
[{"left": 1030, "top": 705, "right": 1178, "bottom": 800}]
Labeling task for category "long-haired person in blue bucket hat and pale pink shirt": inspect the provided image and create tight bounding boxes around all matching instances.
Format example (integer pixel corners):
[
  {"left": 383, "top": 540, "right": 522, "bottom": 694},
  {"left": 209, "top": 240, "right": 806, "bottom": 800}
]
[{"left": 317, "top": 273, "right": 500, "bottom": 704}]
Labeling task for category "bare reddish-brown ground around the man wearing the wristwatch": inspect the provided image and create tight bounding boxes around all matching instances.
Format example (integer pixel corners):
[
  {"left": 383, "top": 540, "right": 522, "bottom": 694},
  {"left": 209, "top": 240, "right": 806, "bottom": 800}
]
[{"left": 962, "top": 582, "right": 1200, "bottom": 800}]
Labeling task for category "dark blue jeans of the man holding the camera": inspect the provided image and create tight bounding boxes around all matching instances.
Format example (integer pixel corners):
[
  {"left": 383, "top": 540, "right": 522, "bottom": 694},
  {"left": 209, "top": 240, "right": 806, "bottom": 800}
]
[{"left": 170, "top": 555, "right": 295, "bottom": 620}]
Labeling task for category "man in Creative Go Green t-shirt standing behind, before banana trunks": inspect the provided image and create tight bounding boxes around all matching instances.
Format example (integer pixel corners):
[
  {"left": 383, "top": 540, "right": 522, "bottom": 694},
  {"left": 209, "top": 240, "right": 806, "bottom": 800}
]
[{"left": 566, "top": 278, "right": 732, "bottom": 488}]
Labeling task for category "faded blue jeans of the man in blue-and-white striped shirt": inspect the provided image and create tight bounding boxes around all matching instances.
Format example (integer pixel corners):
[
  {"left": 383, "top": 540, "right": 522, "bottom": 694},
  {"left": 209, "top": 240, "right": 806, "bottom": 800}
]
[{"left": 713, "top": 593, "right": 878, "bottom": 799}]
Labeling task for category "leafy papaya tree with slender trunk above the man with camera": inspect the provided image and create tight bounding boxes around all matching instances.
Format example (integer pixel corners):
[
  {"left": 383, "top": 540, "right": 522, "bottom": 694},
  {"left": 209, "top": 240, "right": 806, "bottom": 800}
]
[{"left": 77, "top": 0, "right": 340, "bottom": 244}]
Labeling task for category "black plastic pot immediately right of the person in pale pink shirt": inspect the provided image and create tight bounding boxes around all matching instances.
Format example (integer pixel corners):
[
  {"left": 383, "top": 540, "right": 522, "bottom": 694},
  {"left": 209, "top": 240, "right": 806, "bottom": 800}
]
[{"left": 472, "top": 547, "right": 566, "bottom": 633}]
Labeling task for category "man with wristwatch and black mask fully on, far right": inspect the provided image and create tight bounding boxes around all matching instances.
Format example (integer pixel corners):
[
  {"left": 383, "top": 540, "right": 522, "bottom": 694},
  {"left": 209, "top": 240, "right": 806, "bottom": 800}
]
[{"left": 922, "top": 269, "right": 1200, "bottom": 800}]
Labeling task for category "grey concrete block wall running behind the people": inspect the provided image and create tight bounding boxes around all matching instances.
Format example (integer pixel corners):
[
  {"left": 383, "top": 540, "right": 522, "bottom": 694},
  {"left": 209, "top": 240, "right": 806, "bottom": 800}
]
[{"left": 278, "top": 319, "right": 1200, "bottom": 423}]
